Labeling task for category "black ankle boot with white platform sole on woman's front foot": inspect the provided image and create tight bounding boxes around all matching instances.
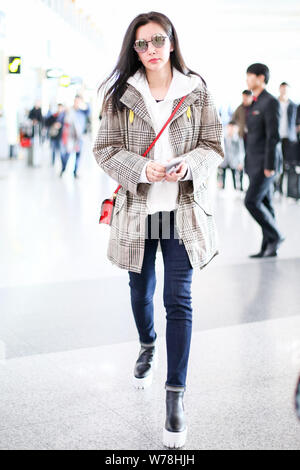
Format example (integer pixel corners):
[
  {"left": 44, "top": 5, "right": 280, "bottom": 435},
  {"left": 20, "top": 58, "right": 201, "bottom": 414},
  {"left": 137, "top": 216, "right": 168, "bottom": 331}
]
[{"left": 163, "top": 390, "right": 187, "bottom": 449}]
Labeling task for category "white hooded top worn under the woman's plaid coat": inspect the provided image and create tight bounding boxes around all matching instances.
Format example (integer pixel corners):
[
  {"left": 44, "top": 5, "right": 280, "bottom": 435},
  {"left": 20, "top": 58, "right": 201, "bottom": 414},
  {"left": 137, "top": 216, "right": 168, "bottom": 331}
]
[{"left": 127, "top": 67, "right": 200, "bottom": 214}]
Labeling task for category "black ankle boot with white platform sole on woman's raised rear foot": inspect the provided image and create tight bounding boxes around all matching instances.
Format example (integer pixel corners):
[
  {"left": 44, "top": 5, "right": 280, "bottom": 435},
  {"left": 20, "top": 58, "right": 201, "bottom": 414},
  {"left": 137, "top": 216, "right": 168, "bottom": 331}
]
[{"left": 133, "top": 346, "right": 157, "bottom": 388}]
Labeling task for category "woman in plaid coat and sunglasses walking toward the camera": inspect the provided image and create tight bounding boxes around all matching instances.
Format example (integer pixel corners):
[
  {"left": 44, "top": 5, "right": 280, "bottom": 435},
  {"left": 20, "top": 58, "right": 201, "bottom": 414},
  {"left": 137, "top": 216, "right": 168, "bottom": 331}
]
[{"left": 94, "top": 12, "right": 224, "bottom": 448}]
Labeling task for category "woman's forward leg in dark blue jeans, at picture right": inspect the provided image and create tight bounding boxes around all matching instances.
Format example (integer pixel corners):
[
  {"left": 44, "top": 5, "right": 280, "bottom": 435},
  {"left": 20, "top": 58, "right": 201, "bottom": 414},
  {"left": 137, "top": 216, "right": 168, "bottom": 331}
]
[{"left": 161, "top": 211, "right": 193, "bottom": 391}]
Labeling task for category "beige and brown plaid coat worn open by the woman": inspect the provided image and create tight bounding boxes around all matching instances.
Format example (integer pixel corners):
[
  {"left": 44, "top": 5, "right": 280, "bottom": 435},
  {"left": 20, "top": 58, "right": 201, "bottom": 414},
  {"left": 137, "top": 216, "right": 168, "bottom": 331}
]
[{"left": 93, "top": 79, "right": 224, "bottom": 273}]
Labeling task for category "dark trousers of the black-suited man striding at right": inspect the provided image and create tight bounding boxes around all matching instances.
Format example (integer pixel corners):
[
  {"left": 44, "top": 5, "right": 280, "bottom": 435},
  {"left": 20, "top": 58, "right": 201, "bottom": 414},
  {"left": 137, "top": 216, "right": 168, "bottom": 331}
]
[{"left": 245, "top": 172, "right": 281, "bottom": 248}]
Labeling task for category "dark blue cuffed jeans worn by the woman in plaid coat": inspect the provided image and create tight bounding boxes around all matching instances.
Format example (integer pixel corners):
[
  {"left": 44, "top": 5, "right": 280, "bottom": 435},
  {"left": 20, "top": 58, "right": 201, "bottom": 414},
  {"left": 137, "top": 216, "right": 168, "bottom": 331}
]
[{"left": 128, "top": 211, "right": 193, "bottom": 390}]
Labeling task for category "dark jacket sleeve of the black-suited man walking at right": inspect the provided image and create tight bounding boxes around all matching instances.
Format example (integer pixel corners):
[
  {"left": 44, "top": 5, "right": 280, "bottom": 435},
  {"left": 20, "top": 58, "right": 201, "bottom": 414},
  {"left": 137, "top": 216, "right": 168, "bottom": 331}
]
[{"left": 264, "top": 98, "right": 280, "bottom": 170}]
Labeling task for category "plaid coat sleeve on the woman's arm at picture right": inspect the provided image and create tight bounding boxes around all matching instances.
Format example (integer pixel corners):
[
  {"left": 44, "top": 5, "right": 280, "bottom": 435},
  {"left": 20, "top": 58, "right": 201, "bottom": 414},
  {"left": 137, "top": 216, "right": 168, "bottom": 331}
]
[{"left": 179, "top": 88, "right": 224, "bottom": 191}]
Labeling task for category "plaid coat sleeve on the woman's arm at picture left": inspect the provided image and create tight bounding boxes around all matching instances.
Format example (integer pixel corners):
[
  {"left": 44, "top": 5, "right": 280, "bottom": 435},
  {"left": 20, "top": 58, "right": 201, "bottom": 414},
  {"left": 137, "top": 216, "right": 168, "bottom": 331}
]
[{"left": 93, "top": 98, "right": 149, "bottom": 195}]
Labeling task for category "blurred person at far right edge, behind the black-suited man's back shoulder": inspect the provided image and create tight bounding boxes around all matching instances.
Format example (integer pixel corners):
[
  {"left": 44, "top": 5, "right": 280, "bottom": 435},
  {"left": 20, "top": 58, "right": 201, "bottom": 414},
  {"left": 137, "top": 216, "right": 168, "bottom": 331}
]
[{"left": 276, "top": 82, "right": 297, "bottom": 194}]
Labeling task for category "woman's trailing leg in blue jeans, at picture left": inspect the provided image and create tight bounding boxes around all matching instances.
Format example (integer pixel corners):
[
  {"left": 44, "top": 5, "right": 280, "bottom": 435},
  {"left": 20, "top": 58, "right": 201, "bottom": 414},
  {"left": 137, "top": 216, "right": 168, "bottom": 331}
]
[{"left": 128, "top": 215, "right": 158, "bottom": 345}]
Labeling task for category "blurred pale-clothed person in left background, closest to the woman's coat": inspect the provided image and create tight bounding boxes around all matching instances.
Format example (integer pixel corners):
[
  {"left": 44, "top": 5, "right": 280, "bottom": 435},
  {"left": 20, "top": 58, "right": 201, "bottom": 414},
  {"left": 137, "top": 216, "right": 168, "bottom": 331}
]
[{"left": 60, "top": 95, "right": 89, "bottom": 178}]
